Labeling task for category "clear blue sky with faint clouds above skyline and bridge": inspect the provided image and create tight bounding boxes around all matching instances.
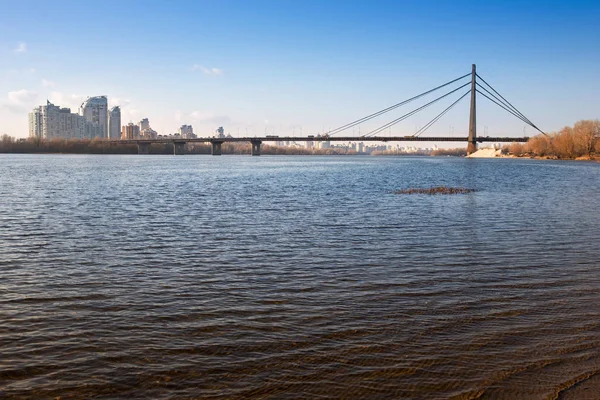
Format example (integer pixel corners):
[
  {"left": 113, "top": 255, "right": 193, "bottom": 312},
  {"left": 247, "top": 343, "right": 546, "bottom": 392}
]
[{"left": 0, "top": 0, "right": 600, "bottom": 137}]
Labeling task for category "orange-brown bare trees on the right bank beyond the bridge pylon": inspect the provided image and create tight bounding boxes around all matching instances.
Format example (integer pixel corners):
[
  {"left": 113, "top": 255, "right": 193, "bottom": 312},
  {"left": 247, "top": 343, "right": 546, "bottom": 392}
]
[{"left": 503, "top": 119, "right": 600, "bottom": 160}]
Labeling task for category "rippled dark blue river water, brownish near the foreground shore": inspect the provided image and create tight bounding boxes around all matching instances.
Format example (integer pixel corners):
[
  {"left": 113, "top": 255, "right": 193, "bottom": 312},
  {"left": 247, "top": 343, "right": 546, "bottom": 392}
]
[{"left": 0, "top": 155, "right": 600, "bottom": 399}]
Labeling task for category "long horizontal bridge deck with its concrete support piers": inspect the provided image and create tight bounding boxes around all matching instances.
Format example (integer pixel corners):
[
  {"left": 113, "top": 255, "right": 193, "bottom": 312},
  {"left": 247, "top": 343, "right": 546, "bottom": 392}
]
[{"left": 117, "top": 136, "right": 529, "bottom": 156}]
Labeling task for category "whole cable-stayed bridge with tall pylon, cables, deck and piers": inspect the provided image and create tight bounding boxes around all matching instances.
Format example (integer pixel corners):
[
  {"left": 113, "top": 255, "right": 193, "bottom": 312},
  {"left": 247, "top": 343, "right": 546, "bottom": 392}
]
[{"left": 115, "top": 64, "right": 546, "bottom": 156}]
